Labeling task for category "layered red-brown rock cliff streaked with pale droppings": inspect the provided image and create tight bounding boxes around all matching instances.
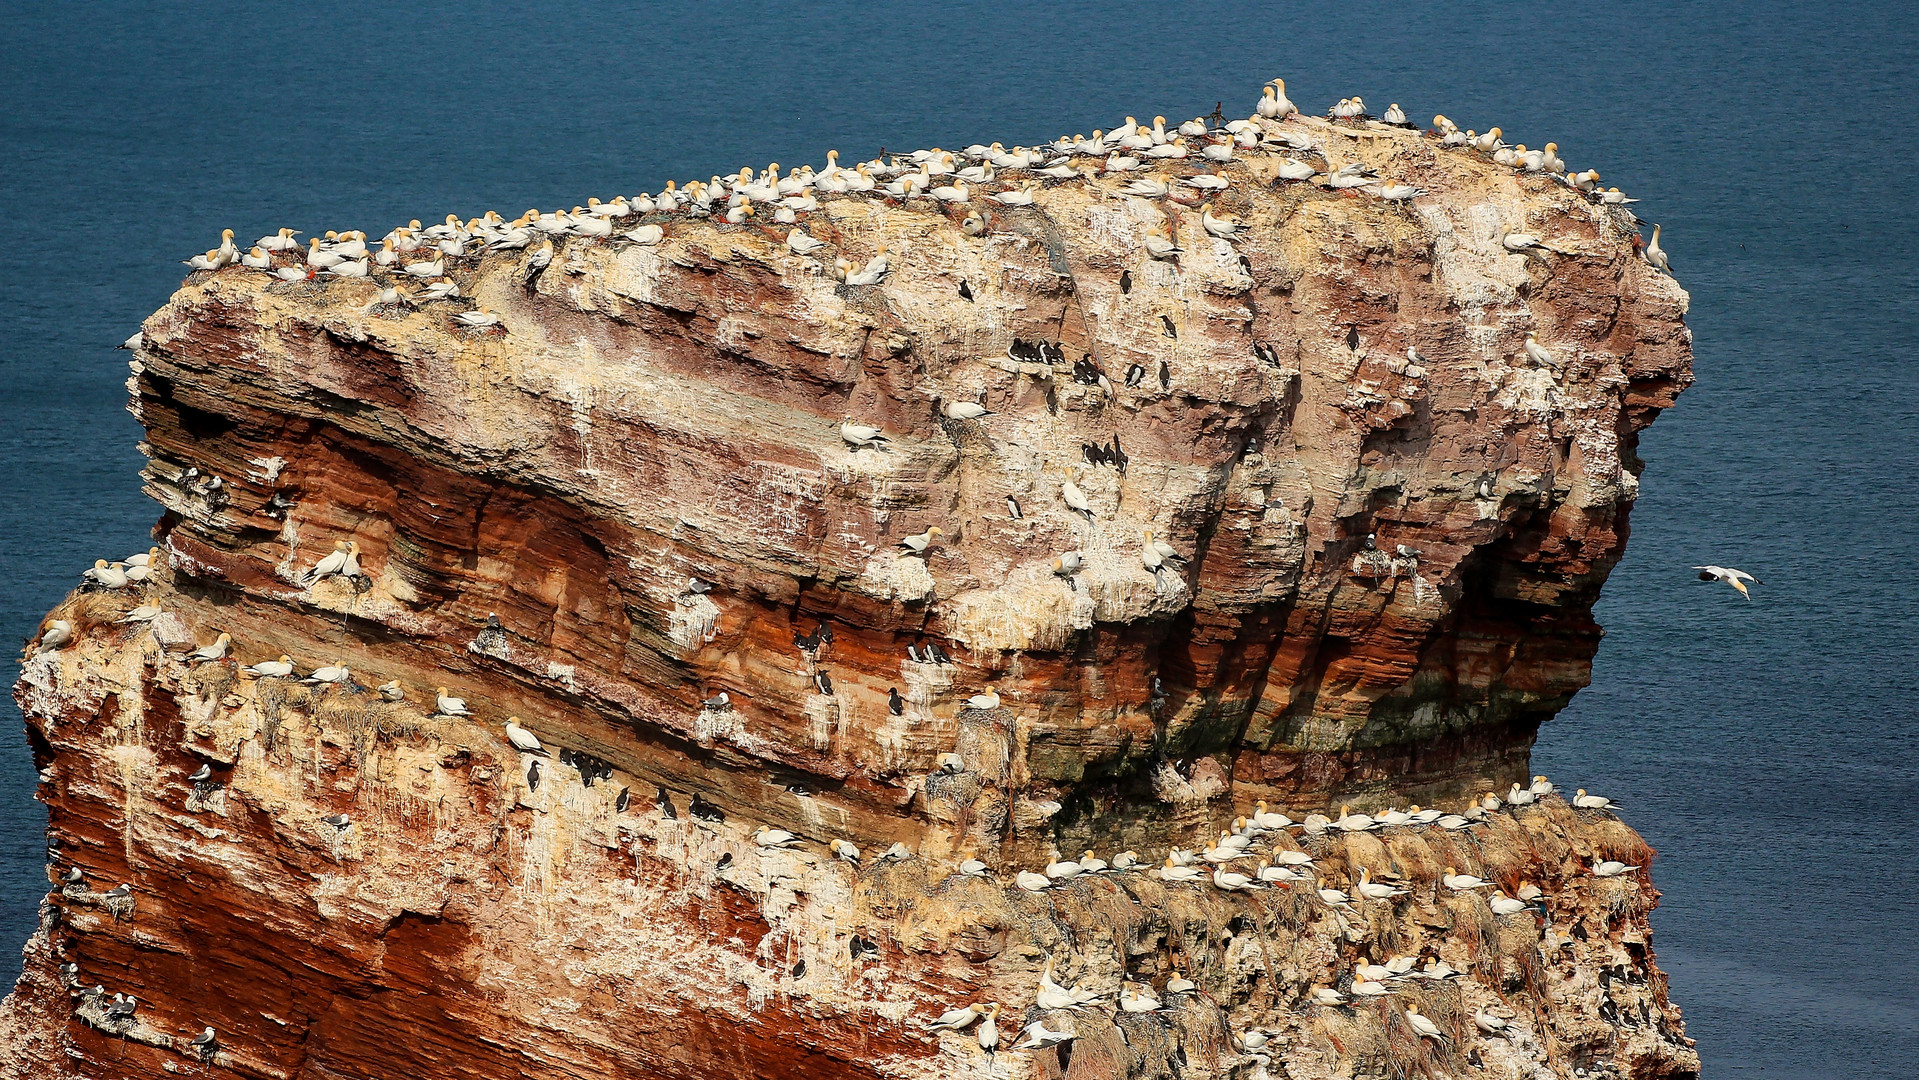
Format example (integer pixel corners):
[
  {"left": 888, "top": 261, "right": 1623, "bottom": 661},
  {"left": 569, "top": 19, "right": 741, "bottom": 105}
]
[{"left": 6, "top": 101, "right": 1696, "bottom": 1078}]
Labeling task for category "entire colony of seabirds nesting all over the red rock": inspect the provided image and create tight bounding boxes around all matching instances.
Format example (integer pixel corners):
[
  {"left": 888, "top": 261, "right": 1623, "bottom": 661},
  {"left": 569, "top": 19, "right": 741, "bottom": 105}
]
[{"left": 33, "top": 81, "right": 1688, "bottom": 1074}]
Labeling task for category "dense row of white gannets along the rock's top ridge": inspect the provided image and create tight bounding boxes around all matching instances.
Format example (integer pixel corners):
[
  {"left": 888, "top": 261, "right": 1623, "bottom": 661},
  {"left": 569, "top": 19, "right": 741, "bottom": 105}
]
[{"left": 172, "top": 79, "right": 1670, "bottom": 352}]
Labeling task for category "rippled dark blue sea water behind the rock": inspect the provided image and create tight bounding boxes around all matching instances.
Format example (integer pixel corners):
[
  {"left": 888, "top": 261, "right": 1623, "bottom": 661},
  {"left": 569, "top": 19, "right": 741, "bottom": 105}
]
[{"left": 0, "top": 0, "right": 1919, "bottom": 1080}]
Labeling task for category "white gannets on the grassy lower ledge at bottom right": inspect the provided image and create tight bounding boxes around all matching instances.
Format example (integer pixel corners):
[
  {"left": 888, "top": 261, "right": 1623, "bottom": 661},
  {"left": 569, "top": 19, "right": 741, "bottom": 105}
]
[{"left": 909, "top": 777, "right": 1639, "bottom": 1057}]
